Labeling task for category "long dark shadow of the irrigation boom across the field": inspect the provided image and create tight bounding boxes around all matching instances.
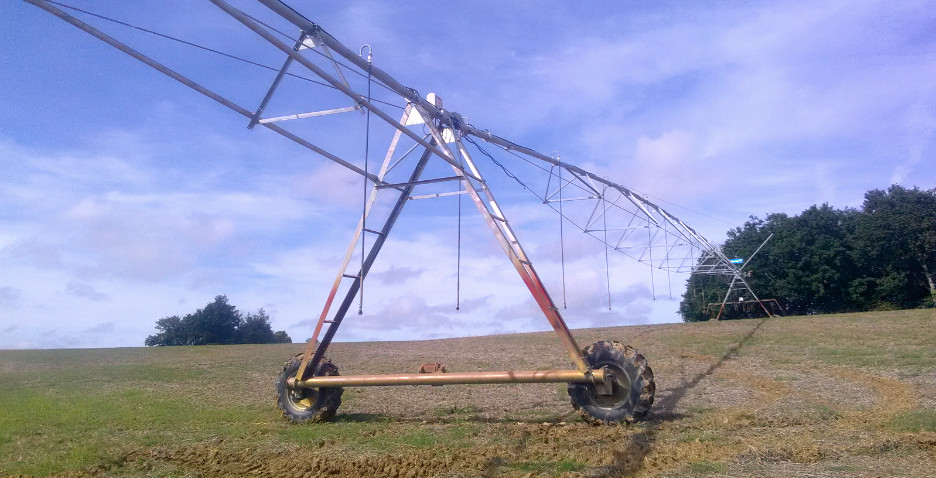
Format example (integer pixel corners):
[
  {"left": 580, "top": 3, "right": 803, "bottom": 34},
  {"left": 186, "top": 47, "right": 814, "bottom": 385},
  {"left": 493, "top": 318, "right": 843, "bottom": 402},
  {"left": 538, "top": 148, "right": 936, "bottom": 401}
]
[{"left": 586, "top": 319, "right": 767, "bottom": 477}]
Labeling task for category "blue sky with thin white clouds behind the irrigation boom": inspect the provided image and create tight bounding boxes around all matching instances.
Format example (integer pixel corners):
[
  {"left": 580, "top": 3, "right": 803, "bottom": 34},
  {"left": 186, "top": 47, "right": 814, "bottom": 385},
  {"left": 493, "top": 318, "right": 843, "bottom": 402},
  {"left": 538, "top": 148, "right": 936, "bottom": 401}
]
[{"left": 0, "top": 0, "right": 936, "bottom": 348}]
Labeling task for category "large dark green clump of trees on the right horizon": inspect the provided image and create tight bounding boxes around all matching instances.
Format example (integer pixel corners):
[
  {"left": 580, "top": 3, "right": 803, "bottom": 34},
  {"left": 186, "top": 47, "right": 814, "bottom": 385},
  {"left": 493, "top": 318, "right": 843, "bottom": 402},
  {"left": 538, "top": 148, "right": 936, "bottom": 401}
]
[{"left": 679, "top": 185, "right": 936, "bottom": 322}]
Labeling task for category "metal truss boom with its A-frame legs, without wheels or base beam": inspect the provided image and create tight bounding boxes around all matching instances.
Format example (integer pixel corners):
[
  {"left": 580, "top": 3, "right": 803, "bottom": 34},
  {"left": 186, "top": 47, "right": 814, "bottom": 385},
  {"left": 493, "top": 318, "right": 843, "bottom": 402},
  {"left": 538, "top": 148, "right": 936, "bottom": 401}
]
[{"left": 25, "top": 0, "right": 772, "bottom": 374}]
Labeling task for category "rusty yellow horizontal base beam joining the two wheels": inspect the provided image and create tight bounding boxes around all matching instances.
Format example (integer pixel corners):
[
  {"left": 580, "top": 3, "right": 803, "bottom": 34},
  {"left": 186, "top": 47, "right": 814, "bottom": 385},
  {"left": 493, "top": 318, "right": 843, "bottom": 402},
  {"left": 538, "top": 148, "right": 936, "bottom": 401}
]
[{"left": 288, "top": 369, "right": 605, "bottom": 388}]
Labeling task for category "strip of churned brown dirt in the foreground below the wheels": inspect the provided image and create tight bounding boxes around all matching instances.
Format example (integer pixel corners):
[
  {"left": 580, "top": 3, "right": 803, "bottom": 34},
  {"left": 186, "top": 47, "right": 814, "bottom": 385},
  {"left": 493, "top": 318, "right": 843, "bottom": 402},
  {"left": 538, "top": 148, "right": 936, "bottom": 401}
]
[{"left": 80, "top": 423, "right": 650, "bottom": 478}]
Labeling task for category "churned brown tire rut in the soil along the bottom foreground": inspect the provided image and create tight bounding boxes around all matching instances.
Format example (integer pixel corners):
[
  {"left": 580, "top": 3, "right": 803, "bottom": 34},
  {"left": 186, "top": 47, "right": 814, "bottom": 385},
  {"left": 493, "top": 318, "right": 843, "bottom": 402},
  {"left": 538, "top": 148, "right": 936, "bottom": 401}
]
[{"left": 113, "top": 430, "right": 644, "bottom": 478}]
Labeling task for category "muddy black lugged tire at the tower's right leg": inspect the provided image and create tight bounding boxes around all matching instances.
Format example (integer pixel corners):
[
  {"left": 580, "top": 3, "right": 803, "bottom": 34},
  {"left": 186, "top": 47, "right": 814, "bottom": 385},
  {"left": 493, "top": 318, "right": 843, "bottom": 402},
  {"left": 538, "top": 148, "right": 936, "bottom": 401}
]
[{"left": 569, "top": 340, "right": 656, "bottom": 425}]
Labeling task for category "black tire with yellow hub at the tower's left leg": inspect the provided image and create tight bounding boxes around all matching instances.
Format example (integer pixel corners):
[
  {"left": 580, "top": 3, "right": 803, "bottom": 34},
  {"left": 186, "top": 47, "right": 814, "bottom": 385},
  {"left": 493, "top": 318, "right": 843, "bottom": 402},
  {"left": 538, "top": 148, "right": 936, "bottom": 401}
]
[{"left": 276, "top": 354, "right": 344, "bottom": 423}]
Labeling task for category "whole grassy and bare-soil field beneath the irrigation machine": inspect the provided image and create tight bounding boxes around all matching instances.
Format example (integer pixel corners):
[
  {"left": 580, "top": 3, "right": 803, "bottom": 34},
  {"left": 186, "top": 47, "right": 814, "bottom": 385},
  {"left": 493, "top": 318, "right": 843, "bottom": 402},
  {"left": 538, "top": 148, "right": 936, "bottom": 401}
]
[{"left": 0, "top": 310, "right": 936, "bottom": 477}]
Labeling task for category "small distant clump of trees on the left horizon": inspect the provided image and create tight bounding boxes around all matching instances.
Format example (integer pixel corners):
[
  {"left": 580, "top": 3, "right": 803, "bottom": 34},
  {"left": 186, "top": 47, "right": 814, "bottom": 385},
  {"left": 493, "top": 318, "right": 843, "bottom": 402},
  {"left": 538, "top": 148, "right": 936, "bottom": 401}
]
[{"left": 145, "top": 295, "right": 292, "bottom": 346}]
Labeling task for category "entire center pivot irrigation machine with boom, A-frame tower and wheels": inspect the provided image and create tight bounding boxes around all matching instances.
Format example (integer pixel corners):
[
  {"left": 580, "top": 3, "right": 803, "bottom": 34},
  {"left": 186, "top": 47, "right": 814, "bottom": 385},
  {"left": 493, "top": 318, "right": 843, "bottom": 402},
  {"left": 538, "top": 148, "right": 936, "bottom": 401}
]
[{"left": 25, "top": 0, "right": 770, "bottom": 423}]
